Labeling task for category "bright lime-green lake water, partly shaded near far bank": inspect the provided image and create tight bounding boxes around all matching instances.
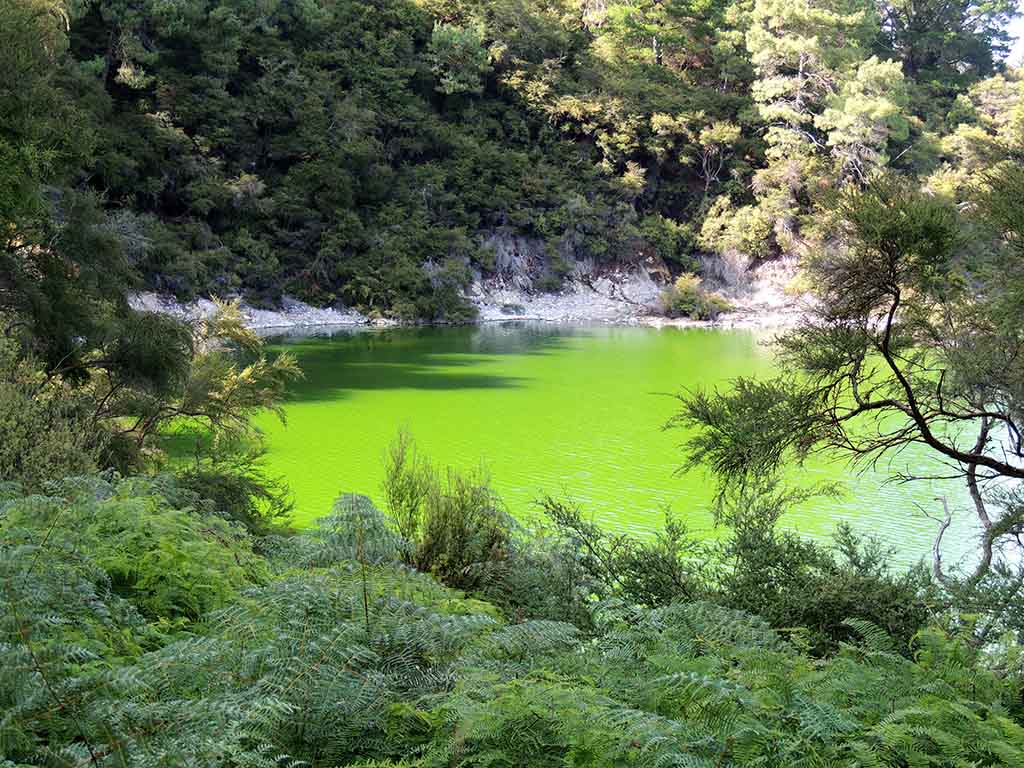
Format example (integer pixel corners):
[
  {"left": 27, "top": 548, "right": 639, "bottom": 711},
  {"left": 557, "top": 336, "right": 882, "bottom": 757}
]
[{"left": 258, "top": 325, "right": 971, "bottom": 559}]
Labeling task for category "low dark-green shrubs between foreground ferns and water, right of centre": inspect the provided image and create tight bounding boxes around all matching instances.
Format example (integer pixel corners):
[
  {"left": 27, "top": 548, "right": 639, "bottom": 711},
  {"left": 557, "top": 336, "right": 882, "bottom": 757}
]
[{"left": 479, "top": 481, "right": 944, "bottom": 656}]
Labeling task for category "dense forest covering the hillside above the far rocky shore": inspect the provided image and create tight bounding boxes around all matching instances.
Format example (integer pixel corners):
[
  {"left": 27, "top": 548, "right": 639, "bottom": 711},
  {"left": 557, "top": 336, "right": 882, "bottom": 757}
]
[{"left": 0, "top": 0, "right": 1020, "bottom": 321}]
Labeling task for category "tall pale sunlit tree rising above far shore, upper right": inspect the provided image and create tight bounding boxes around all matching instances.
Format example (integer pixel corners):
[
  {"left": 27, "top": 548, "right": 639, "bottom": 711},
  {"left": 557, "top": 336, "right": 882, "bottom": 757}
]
[{"left": 705, "top": 0, "right": 907, "bottom": 264}]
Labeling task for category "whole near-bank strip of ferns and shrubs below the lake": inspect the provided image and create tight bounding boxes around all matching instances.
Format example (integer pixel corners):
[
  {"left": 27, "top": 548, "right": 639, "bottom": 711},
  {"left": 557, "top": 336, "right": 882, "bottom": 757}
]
[{"left": 6, "top": 439, "right": 1024, "bottom": 767}]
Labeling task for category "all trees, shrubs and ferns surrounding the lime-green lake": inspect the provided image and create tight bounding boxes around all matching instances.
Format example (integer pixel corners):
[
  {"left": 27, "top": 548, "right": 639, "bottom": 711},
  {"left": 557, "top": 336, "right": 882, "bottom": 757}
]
[{"left": 0, "top": 0, "right": 1024, "bottom": 768}]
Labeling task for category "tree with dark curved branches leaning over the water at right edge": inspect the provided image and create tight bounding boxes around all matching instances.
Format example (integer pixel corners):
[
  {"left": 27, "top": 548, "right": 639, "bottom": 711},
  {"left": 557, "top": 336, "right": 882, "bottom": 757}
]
[{"left": 670, "top": 177, "right": 1024, "bottom": 638}]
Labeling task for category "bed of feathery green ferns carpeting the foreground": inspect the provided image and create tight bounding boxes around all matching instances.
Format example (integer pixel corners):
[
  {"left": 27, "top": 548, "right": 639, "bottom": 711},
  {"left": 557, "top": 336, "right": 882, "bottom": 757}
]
[{"left": 0, "top": 480, "right": 1024, "bottom": 768}]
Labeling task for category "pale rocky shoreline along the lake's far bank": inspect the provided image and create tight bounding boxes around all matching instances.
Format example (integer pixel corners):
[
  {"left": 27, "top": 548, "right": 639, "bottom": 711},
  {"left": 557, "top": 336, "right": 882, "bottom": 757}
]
[{"left": 129, "top": 270, "right": 801, "bottom": 332}]
